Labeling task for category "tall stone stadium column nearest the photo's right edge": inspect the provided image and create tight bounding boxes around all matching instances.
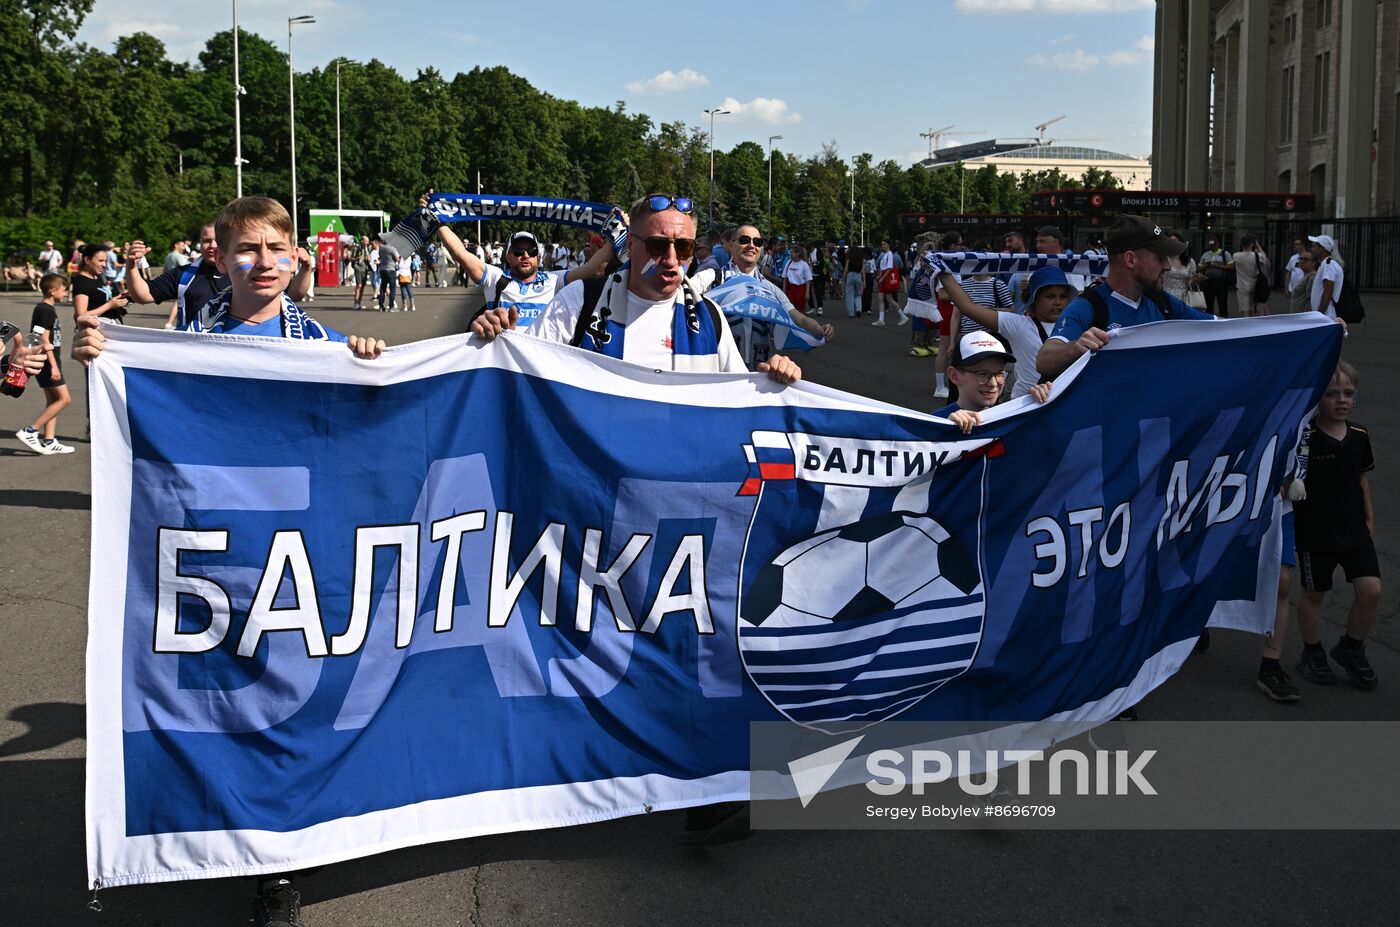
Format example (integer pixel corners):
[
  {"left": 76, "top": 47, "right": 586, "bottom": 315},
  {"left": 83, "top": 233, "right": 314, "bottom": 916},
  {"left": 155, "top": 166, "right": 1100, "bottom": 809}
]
[{"left": 1337, "top": 0, "right": 1376, "bottom": 218}]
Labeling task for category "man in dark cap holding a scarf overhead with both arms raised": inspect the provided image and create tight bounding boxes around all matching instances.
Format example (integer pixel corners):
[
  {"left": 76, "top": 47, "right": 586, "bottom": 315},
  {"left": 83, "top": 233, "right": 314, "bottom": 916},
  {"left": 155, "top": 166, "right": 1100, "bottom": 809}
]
[{"left": 419, "top": 190, "right": 613, "bottom": 328}]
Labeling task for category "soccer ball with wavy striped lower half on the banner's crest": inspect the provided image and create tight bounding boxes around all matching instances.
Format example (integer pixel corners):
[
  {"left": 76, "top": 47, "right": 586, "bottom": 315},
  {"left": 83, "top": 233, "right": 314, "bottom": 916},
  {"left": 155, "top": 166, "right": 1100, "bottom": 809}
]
[{"left": 739, "top": 513, "right": 984, "bottom": 734}]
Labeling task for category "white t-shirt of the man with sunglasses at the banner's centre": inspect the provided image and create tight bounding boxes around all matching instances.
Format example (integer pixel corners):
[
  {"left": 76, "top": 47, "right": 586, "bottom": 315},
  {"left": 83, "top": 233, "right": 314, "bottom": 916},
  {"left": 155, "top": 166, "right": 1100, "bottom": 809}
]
[{"left": 529, "top": 280, "right": 749, "bottom": 374}]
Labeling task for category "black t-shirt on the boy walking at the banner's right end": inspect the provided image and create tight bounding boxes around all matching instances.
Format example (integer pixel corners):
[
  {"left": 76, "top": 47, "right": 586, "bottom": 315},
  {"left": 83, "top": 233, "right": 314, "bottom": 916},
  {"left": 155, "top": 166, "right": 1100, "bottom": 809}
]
[{"left": 1294, "top": 421, "right": 1376, "bottom": 550}]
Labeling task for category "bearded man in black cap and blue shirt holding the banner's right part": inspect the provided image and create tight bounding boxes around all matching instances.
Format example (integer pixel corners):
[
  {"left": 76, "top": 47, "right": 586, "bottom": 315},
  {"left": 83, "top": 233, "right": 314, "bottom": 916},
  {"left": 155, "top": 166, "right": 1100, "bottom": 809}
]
[{"left": 1036, "top": 216, "right": 1215, "bottom": 377}]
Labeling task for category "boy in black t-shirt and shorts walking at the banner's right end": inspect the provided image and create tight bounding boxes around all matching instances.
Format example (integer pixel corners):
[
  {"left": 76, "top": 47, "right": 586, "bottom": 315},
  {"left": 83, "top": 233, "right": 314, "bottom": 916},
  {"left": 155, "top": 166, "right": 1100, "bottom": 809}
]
[{"left": 1294, "top": 361, "right": 1380, "bottom": 689}]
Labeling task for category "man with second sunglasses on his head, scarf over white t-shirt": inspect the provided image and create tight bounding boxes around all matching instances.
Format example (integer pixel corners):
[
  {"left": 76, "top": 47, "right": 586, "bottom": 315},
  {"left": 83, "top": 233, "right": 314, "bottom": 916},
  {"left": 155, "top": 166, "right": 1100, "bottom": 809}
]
[{"left": 472, "top": 195, "right": 802, "bottom": 384}]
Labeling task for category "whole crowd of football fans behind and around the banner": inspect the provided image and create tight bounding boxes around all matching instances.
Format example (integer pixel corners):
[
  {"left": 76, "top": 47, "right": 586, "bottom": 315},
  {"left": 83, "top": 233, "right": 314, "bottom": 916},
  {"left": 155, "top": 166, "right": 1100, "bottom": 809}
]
[{"left": 6, "top": 195, "right": 1380, "bottom": 924}]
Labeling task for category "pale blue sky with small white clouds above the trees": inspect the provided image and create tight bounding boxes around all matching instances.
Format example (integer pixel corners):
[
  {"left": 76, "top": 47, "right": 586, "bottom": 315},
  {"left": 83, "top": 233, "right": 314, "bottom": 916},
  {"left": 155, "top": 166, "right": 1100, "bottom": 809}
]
[{"left": 78, "top": 0, "right": 1154, "bottom": 164}]
